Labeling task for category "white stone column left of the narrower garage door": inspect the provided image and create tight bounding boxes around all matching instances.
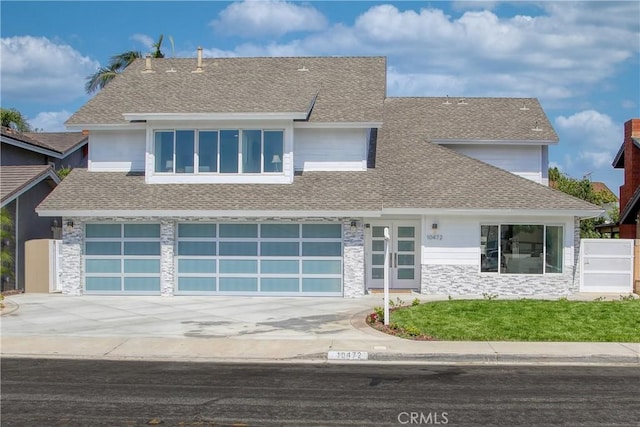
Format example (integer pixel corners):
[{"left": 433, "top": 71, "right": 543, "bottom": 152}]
[{"left": 61, "top": 217, "right": 84, "bottom": 295}]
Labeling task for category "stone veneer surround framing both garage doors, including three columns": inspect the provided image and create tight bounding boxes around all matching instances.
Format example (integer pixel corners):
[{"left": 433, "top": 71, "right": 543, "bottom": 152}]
[{"left": 62, "top": 217, "right": 365, "bottom": 297}]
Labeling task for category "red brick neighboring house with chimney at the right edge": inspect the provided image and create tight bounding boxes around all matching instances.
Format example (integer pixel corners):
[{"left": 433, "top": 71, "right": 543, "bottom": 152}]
[{"left": 613, "top": 119, "right": 640, "bottom": 239}]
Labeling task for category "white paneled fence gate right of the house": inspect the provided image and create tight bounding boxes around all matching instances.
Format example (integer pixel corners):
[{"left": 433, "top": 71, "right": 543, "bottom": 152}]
[{"left": 580, "top": 239, "right": 635, "bottom": 294}]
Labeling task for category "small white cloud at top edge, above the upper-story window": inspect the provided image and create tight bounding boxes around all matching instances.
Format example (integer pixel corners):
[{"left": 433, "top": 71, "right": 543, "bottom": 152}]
[{"left": 211, "top": 0, "right": 327, "bottom": 37}]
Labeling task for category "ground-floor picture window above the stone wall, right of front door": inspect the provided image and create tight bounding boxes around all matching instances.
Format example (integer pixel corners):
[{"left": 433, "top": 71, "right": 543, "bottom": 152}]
[{"left": 480, "top": 224, "right": 564, "bottom": 274}]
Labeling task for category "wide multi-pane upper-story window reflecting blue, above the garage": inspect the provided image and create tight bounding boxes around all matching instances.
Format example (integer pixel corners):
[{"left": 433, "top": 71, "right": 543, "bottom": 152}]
[{"left": 154, "top": 129, "right": 284, "bottom": 174}]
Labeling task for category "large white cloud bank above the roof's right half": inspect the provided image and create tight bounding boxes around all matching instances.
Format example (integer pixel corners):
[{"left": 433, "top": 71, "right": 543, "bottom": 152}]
[{"left": 208, "top": 2, "right": 640, "bottom": 101}]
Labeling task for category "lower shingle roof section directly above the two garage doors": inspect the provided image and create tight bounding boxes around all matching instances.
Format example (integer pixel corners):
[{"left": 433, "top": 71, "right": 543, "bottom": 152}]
[{"left": 38, "top": 169, "right": 382, "bottom": 211}]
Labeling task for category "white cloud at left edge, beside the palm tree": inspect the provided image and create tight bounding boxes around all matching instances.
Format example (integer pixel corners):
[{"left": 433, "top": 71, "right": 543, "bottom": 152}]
[{"left": 0, "top": 36, "right": 99, "bottom": 104}]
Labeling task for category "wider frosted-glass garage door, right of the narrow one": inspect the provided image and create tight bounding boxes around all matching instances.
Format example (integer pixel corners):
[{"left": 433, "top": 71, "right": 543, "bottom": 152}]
[{"left": 176, "top": 223, "right": 342, "bottom": 296}]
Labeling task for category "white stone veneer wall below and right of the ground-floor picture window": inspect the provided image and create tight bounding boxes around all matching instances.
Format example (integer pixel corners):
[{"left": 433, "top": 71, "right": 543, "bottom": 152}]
[{"left": 421, "top": 218, "right": 580, "bottom": 297}]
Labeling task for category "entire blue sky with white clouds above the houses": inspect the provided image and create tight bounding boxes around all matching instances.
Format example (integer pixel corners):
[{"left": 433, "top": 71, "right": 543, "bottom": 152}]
[{"left": 0, "top": 0, "right": 640, "bottom": 193}]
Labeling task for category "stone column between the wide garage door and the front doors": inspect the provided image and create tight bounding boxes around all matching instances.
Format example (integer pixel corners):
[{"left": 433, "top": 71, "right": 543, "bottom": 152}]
[{"left": 342, "top": 219, "right": 365, "bottom": 298}]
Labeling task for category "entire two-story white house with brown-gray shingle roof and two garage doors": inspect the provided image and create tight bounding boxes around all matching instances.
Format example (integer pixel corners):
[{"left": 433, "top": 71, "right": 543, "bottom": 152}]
[{"left": 38, "top": 51, "right": 601, "bottom": 297}]
